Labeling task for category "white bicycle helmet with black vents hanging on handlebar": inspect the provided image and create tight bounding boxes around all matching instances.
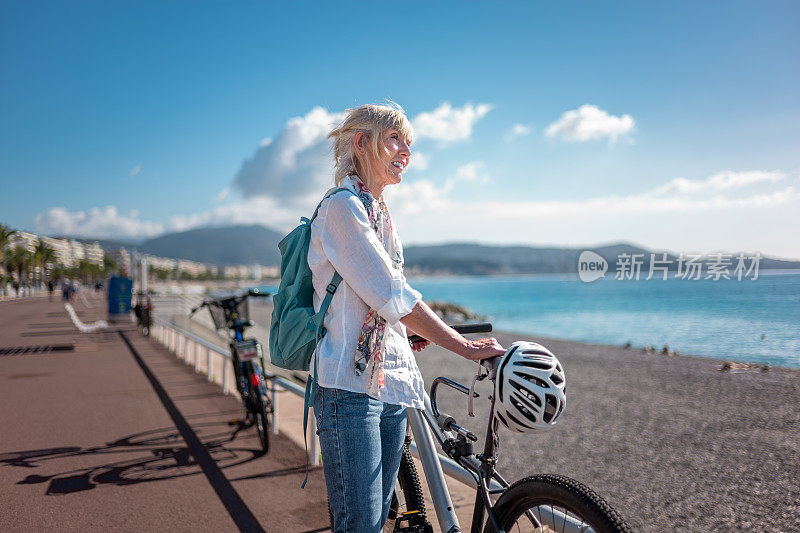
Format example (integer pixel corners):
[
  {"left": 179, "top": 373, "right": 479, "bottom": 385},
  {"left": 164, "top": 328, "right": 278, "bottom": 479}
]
[{"left": 494, "top": 341, "right": 567, "bottom": 433}]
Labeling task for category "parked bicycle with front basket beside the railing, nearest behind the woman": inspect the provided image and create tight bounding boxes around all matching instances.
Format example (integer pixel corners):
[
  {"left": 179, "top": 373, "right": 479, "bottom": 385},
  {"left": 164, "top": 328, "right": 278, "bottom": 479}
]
[{"left": 189, "top": 289, "right": 274, "bottom": 453}]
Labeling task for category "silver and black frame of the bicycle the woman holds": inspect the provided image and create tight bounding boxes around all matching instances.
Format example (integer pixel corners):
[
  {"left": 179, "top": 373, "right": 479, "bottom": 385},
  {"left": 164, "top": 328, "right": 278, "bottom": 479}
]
[{"left": 406, "top": 378, "right": 596, "bottom": 533}]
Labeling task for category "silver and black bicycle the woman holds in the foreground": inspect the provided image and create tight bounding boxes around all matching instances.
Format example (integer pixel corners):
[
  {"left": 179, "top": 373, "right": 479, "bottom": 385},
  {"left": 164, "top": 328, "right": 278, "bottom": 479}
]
[{"left": 382, "top": 323, "right": 630, "bottom": 533}]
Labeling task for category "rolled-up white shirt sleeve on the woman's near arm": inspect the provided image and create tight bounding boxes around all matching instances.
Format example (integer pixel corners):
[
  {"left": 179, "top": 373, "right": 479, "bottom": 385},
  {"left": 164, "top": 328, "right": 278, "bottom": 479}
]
[{"left": 317, "top": 194, "right": 422, "bottom": 325}]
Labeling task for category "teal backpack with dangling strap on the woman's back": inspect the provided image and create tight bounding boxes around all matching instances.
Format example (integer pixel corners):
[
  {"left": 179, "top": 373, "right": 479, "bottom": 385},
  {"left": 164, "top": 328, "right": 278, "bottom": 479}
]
[{"left": 269, "top": 187, "right": 355, "bottom": 487}]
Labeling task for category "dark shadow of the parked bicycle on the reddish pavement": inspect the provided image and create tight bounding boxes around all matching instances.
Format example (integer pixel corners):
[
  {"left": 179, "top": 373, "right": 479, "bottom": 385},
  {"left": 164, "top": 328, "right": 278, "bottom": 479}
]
[{"left": 0, "top": 421, "right": 270, "bottom": 495}]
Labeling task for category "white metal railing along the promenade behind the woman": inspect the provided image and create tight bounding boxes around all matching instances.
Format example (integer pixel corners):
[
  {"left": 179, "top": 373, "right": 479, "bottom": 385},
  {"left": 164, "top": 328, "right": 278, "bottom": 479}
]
[{"left": 151, "top": 316, "right": 319, "bottom": 465}]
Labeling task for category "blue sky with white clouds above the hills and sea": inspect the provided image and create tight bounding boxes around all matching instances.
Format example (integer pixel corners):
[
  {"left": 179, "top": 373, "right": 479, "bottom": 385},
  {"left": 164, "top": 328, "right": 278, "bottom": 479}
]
[{"left": 0, "top": 1, "right": 800, "bottom": 257}]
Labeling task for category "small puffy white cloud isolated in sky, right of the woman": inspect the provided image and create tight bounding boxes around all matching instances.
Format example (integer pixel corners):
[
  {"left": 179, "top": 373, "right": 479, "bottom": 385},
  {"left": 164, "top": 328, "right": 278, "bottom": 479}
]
[{"left": 544, "top": 104, "right": 636, "bottom": 143}]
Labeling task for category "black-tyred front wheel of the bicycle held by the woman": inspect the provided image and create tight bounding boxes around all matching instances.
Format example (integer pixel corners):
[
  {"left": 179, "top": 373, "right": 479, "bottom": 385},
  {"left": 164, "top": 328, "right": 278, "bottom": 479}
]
[{"left": 484, "top": 474, "right": 631, "bottom": 533}]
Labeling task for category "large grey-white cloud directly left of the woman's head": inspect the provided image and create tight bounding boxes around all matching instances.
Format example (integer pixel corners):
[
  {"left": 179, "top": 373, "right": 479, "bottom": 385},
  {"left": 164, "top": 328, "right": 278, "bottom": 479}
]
[{"left": 233, "top": 107, "right": 343, "bottom": 204}]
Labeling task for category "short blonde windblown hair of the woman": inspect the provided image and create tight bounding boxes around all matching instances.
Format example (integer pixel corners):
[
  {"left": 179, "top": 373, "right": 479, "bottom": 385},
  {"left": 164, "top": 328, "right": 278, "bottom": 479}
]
[{"left": 328, "top": 101, "right": 414, "bottom": 185}]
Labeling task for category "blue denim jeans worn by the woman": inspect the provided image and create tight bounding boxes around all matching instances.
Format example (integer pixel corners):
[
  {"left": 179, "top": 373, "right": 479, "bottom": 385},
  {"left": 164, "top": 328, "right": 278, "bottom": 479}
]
[{"left": 314, "top": 387, "right": 406, "bottom": 533}]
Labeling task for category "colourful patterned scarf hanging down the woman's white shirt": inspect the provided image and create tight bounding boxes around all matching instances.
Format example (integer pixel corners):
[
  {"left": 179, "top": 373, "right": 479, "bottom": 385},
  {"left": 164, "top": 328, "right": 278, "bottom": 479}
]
[{"left": 350, "top": 175, "right": 403, "bottom": 397}]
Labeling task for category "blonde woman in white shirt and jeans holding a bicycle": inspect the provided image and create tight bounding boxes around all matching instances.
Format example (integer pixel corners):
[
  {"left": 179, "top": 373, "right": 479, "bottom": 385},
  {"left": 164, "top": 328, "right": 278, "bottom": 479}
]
[{"left": 308, "top": 105, "right": 504, "bottom": 533}]
